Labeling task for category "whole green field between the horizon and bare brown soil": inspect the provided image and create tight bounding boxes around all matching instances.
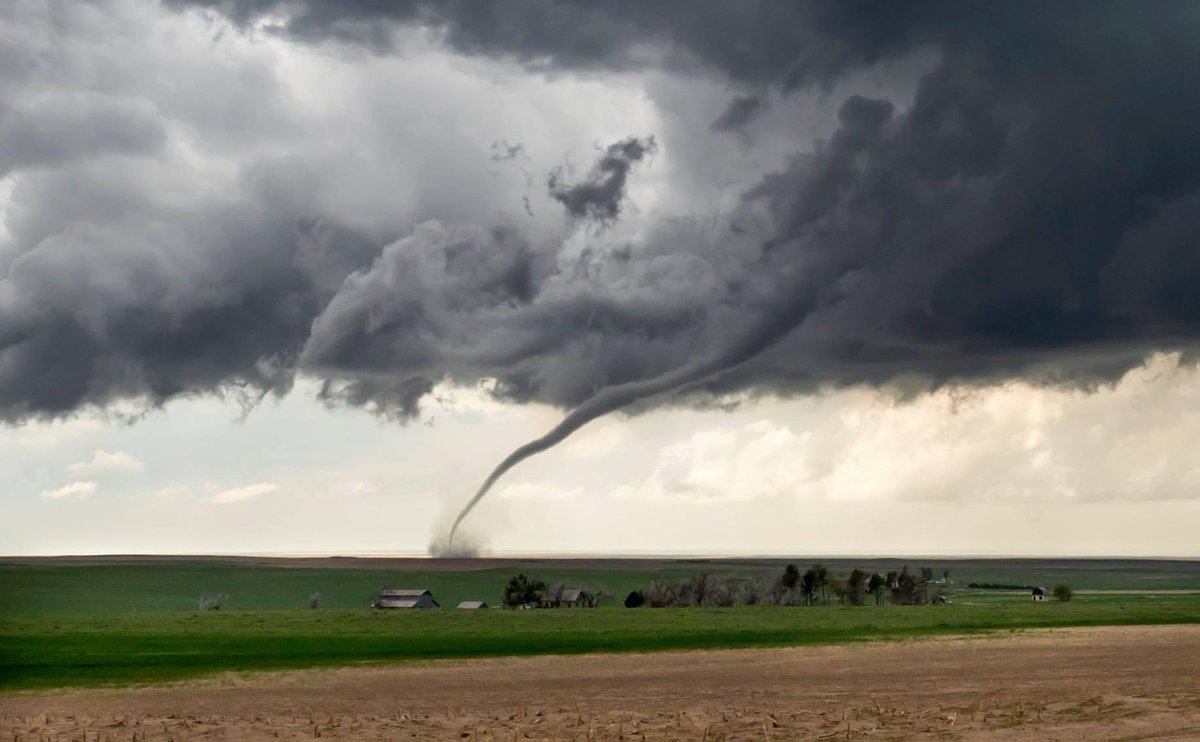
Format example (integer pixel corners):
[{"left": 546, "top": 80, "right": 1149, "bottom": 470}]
[{"left": 0, "top": 560, "right": 1200, "bottom": 690}]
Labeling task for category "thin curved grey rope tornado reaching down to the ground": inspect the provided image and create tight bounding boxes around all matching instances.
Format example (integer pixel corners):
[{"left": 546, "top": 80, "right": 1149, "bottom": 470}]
[{"left": 446, "top": 292, "right": 812, "bottom": 550}]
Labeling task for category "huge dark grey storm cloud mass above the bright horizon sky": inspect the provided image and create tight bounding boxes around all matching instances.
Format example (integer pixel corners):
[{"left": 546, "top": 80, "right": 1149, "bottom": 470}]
[{"left": 0, "top": 0, "right": 1200, "bottom": 420}]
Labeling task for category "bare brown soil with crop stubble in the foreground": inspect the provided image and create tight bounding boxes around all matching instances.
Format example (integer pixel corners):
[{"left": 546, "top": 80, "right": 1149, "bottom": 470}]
[{"left": 0, "top": 626, "right": 1200, "bottom": 740}]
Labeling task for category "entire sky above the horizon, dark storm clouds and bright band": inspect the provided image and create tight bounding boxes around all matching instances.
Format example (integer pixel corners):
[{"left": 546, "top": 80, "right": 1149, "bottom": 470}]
[{"left": 0, "top": 0, "right": 1200, "bottom": 557}]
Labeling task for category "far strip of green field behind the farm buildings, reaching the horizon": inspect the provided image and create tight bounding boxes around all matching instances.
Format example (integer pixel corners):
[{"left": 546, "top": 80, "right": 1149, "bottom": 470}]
[{"left": 0, "top": 557, "right": 1200, "bottom": 609}]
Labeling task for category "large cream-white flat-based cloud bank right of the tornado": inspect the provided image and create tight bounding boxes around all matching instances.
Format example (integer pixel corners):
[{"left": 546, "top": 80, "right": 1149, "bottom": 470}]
[{"left": 613, "top": 355, "right": 1200, "bottom": 503}]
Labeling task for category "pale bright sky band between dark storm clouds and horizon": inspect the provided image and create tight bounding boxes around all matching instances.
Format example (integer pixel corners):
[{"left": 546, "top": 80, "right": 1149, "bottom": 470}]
[{"left": 0, "top": 357, "right": 1200, "bottom": 556}]
